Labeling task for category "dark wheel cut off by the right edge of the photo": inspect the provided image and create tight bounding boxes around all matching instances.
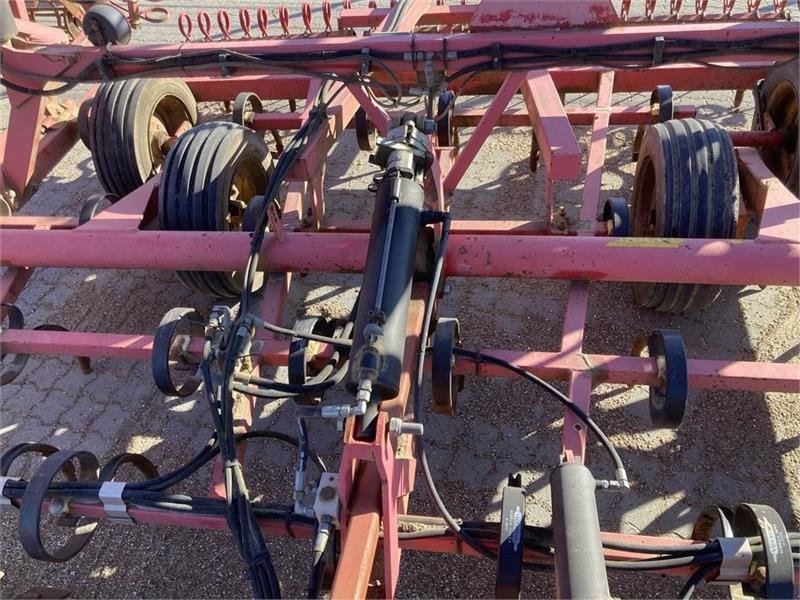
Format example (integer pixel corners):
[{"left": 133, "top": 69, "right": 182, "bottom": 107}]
[{"left": 754, "top": 59, "right": 800, "bottom": 197}]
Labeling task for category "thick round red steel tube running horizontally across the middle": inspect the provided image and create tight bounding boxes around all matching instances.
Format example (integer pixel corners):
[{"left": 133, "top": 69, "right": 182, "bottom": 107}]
[{"left": 0, "top": 229, "right": 800, "bottom": 285}]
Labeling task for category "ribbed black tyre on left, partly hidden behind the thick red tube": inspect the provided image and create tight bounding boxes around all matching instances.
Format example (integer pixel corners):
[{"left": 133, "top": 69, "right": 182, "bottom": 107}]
[{"left": 158, "top": 122, "right": 272, "bottom": 298}]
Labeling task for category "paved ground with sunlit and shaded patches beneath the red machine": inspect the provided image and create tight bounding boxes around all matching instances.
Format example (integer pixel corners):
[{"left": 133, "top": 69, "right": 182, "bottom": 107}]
[{"left": 0, "top": 0, "right": 800, "bottom": 598}]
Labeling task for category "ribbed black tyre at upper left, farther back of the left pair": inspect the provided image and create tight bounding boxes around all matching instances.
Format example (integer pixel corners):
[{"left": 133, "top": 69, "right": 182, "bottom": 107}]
[{"left": 88, "top": 79, "right": 197, "bottom": 198}]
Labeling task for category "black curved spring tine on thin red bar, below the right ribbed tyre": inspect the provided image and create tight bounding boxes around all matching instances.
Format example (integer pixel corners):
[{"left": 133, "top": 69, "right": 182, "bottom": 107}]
[{"left": 647, "top": 330, "right": 689, "bottom": 429}]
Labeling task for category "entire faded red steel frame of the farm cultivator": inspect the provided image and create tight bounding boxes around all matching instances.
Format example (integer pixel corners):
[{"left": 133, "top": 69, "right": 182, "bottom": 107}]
[{"left": 0, "top": 0, "right": 800, "bottom": 598}]
